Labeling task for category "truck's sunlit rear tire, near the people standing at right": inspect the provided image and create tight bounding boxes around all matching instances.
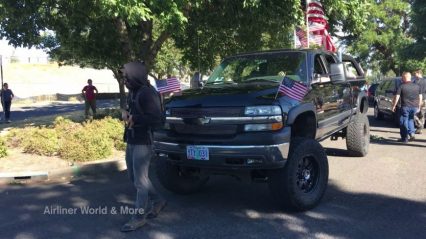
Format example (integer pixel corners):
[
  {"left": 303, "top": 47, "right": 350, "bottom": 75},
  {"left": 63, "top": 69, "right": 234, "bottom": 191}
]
[{"left": 346, "top": 114, "right": 370, "bottom": 157}]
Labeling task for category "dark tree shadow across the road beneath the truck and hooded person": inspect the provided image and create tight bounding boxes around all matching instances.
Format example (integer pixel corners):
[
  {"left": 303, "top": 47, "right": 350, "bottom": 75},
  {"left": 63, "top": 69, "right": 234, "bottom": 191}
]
[{"left": 0, "top": 169, "right": 426, "bottom": 239}]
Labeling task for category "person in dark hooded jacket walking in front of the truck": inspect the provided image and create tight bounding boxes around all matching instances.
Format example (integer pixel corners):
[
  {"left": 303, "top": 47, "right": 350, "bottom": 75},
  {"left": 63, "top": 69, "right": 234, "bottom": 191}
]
[{"left": 121, "top": 62, "right": 166, "bottom": 232}]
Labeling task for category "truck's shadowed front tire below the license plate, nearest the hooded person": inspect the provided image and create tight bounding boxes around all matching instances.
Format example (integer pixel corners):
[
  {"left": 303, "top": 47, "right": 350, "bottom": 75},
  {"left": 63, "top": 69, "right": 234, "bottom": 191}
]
[{"left": 155, "top": 158, "right": 209, "bottom": 194}]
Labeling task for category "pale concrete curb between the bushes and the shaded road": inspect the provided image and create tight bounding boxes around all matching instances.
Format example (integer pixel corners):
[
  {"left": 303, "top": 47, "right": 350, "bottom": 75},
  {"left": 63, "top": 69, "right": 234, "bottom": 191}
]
[{"left": 0, "top": 159, "right": 127, "bottom": 184}]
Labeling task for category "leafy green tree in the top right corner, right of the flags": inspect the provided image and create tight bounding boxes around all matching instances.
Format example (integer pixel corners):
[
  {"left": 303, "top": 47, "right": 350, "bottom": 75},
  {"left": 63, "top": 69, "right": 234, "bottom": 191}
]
[{"left": 344, "top": 0, "right": 424, "bottom": 75}]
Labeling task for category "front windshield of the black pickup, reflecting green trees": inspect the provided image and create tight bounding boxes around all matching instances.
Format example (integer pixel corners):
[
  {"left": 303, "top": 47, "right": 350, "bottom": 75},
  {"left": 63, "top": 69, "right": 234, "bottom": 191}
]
[{"left": 206, "top": 52, "right": 307, "bottom": 85}]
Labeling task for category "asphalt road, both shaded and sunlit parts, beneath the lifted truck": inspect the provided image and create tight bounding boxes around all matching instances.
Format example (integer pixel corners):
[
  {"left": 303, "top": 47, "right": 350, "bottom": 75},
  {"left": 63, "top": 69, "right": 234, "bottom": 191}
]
[{"left": 0, "top": 109, "right": 426, "bottom": 239}]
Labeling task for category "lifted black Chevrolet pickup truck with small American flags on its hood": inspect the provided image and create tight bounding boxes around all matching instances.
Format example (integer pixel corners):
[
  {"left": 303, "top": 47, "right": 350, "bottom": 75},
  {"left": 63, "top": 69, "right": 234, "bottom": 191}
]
[{"left": 154, "top": 49, "right": 370, "bottom": 211}]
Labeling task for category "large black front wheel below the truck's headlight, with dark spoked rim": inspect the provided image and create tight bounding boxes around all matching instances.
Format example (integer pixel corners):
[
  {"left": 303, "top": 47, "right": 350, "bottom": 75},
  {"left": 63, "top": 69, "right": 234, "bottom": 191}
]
[{"left": 269, "top": 138, "right": 328, "bottom": 211}]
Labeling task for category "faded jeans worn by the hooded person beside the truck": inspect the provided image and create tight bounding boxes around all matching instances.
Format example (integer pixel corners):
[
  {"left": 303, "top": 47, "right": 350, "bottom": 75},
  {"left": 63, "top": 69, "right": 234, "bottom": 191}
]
[{"left": 126, "top": 144, "right": 163, "bottom": 215}]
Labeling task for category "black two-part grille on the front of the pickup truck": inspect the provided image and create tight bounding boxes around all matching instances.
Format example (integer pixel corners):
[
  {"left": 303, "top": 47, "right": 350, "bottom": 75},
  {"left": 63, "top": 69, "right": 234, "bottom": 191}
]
[{"left": 171, "top": 107, "right": 244, "bottom": 136}]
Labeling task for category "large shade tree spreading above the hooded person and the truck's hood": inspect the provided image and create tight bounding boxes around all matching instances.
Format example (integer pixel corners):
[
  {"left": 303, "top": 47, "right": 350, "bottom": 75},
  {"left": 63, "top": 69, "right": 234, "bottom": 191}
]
[{"left": 0, "top": 0, "right": 365, "bottom": 107}]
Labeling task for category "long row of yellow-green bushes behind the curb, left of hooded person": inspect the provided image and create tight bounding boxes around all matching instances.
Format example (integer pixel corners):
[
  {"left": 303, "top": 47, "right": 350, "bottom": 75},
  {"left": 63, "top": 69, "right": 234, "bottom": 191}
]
[{"left": 7, "top": 116, "right": 126, "bottom": 161}]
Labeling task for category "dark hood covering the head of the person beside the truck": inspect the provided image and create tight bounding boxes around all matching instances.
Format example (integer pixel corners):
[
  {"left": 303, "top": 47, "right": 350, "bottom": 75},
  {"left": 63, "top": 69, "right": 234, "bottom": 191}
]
[{"left": 121, "top": 61, "right": 149, "bottom": 90}]
